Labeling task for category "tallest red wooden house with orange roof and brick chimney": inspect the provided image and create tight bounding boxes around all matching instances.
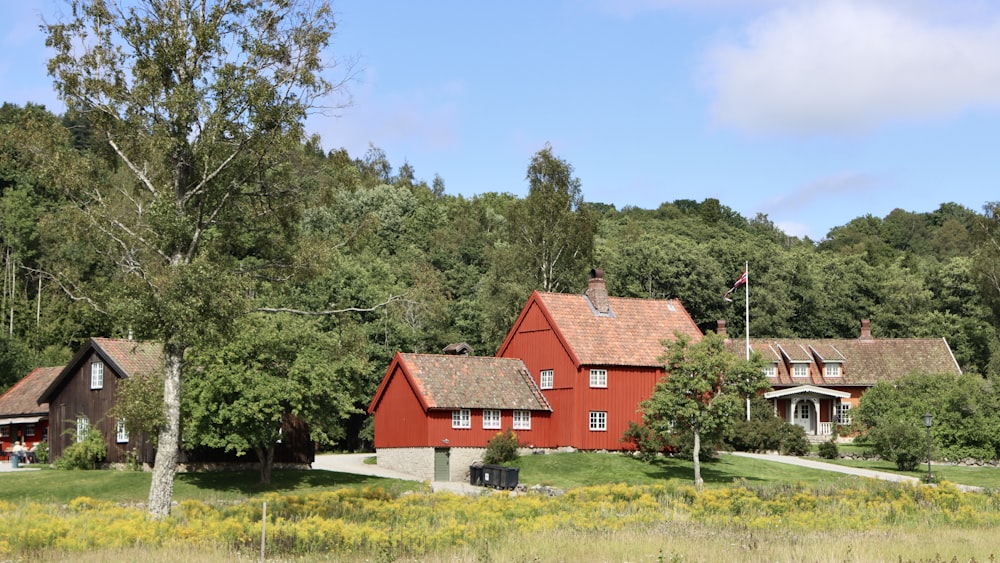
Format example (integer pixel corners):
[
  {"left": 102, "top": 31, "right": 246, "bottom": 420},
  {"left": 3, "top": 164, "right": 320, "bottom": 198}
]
[{"left": 497, "top": 269, "right": 702, "bottom": 450}]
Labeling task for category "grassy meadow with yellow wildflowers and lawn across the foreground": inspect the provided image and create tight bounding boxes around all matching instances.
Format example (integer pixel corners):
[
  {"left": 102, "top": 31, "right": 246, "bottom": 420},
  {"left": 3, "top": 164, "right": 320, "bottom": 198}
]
[{"left": 0, "top": 454, "right": 1000, "bottom": 562}]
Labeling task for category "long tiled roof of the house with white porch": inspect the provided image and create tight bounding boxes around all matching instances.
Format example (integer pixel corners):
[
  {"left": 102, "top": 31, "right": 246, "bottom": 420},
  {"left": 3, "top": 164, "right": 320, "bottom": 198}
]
[{"left": 726, "top": 338, "right": 961, "bottom": 387}]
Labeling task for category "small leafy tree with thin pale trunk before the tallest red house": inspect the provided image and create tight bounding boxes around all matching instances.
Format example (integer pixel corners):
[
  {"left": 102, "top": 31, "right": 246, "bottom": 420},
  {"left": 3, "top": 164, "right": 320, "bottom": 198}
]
[{"left": 640, "top": 332, "right": 767, "bottom": 489}]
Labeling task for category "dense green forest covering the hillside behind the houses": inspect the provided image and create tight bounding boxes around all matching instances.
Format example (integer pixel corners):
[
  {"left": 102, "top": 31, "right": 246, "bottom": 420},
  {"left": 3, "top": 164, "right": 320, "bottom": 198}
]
[{"left": 0, "top": 103, "right": 1000, "bottom": 447}]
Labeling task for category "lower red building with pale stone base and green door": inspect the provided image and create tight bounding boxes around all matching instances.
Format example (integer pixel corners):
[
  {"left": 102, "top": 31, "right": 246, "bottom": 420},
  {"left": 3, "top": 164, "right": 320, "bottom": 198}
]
[{"left": 368, "top": 352, "right": 552, "bottom": 481}]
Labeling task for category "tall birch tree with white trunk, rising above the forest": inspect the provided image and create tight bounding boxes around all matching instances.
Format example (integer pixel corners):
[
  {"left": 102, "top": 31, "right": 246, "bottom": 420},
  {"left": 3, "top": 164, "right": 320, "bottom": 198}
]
[{"left": 44, "top": 0, "right": 344, "bottom": 518}]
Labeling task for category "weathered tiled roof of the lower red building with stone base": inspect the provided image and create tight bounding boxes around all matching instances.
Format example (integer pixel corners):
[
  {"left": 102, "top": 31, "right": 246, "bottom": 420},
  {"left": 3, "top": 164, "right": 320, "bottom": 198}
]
[{"left": 399, "top": 353, "right": 552, "bottom": 411}]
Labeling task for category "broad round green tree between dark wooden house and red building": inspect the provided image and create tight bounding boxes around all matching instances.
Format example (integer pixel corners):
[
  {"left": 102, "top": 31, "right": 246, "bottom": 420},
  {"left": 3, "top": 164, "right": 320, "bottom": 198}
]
[{"left": 184, "top": 313, "right": 361, "bottom": 484}]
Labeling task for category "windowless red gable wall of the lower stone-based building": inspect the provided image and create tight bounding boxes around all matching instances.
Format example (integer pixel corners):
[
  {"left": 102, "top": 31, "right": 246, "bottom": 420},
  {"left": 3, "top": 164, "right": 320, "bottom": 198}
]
[{"left": 375, "top": 364, "right": 428, "bottom": 448}]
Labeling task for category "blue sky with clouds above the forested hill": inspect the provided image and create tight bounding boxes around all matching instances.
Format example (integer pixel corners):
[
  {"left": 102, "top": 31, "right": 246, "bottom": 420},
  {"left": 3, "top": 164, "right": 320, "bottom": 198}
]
[{"left": 0, "top": 0, "right": 1000, "bottom": 240}]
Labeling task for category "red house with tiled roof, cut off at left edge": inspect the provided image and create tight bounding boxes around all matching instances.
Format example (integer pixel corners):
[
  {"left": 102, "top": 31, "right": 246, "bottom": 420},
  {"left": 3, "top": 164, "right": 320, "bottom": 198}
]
[{"left": 0, "top": 367, "right": 62, "bottom": 459}]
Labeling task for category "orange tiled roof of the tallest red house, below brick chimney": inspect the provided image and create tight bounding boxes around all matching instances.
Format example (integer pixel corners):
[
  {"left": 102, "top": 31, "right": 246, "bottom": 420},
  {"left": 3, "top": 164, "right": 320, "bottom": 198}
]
[{"left": 538, "top": 293, "right": 702, "bottom": 366}]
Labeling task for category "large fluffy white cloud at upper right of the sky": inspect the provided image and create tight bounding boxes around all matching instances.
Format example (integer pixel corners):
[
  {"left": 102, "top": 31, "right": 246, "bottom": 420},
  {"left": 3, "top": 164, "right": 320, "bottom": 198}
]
[{"left": 704, "top": 0, "right": 1000, "bottom": 135}]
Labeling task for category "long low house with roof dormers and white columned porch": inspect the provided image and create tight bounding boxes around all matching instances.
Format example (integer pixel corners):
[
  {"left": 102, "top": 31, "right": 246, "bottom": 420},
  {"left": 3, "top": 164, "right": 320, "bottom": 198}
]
[{"left": 718, "top": 320, "right": 962, "bottom": 440}]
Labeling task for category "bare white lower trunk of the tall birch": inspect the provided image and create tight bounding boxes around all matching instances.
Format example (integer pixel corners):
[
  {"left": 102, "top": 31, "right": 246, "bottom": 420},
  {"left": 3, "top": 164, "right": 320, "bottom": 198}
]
[{"left": 149, "top": 343, "right": 184, "bottom": 519}]
